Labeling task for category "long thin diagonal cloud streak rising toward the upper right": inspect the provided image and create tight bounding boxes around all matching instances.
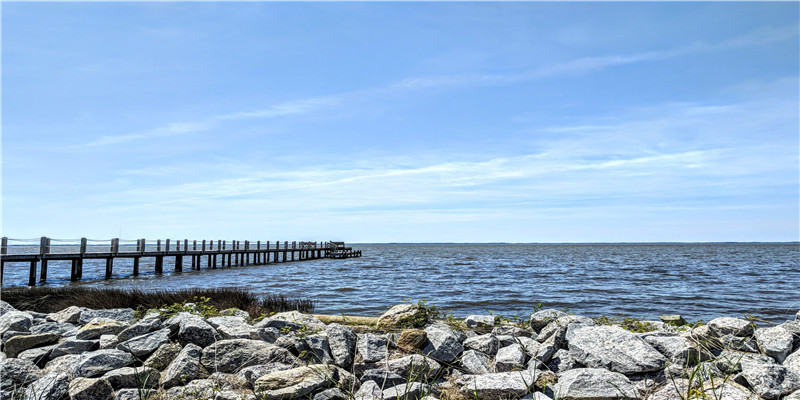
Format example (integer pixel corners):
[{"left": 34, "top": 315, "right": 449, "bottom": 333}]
[{"left": 74, "top": 26, "right": 798, "bottom": 148}]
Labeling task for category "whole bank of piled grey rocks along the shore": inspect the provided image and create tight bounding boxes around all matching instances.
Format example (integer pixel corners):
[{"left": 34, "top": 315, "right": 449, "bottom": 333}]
[{"left": 0, "top": 301, "right": 800, "bottom": 400}]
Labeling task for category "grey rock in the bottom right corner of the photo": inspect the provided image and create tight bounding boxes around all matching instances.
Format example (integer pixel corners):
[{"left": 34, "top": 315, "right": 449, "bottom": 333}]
[{"left": 741, "top": 360, "right": 800, "bottom": 400}]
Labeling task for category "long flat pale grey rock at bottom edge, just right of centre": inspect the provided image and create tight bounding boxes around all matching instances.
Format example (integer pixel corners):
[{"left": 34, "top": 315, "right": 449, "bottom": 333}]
[{"left": 456, "top": 370, "right": 541, "bottom": 400}]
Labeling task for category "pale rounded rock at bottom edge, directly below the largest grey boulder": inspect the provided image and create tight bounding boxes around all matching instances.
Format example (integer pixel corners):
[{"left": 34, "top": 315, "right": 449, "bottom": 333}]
[{"left": 553, "top": 368, "right": 639, "bottom": 400}]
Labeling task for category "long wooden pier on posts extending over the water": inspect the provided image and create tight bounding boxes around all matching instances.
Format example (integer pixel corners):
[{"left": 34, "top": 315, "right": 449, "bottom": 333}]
[{"left": 0, "top": 237, "right": 361, "bottom": 286}]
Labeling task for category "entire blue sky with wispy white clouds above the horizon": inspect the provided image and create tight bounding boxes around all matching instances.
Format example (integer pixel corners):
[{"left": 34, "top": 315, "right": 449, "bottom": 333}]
[{"left": 2, "top": 2, "right": 800, "bottom": 242}]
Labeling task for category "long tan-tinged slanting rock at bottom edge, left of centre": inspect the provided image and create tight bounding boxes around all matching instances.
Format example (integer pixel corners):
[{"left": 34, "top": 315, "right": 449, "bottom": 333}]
[{"left": 254, "top": 364, "right": 355, "bottom": 400}]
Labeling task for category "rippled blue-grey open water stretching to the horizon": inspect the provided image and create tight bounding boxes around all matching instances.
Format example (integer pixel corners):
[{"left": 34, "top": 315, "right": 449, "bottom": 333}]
[{"left": 3, "top": 243, "right": 800, "bottom": 320}]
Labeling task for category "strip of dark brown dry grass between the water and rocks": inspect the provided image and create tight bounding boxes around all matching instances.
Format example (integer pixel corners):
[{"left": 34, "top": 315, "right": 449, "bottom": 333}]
[{"left": 2, "top": 287, "right": 314, "bottom": 318}]
